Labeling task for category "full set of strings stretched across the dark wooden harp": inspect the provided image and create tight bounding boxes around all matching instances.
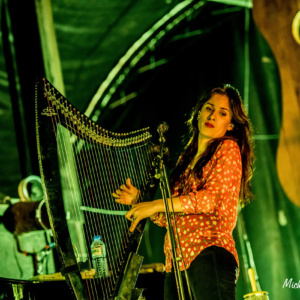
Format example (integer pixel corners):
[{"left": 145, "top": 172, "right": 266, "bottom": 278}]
[{"left": 45, "top": 78, "right": 152, "bottom": 299}]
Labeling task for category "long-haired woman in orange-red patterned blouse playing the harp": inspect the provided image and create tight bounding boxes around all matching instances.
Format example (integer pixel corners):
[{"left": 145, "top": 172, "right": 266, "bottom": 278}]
[{"left": 113, "top": 84, "right": 253, "bottom": 300}]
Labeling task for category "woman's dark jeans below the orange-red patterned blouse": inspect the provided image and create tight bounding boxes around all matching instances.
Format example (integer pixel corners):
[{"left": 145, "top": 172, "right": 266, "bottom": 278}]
[{"left": 164, "top": 246, "right": 237, "bottom": 300}]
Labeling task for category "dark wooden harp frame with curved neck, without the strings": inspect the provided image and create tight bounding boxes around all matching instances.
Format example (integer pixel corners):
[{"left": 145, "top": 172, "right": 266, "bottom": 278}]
[{"left": 35, "top": 78, "right": 157, "bottom": 299}]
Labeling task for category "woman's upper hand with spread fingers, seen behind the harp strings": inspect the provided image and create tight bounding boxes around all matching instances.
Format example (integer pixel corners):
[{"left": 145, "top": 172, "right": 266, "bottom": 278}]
[{"left": 112, "top": 178, "right": 140, "bottom": 205}]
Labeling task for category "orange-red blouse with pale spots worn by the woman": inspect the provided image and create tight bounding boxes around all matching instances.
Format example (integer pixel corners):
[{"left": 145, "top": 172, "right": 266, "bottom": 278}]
[{"left": 151, "top": 140, "right": 242, "bottom": 272}]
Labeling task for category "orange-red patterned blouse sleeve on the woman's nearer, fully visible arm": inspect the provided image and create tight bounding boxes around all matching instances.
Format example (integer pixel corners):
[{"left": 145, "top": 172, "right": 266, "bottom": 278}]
[{"left": 179, "top": 141, "right": 242, "bottom": 214}]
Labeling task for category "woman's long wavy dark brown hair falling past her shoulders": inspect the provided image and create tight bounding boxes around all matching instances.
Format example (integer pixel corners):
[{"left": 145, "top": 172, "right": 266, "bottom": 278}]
[{"left": 170, "top": 84, "right": 254, "bottom": 205}]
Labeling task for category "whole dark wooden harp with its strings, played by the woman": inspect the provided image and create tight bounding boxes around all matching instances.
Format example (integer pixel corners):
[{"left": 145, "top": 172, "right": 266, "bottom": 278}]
[{"left": 35, "top": 79, "right": 157, "bottom": 299}]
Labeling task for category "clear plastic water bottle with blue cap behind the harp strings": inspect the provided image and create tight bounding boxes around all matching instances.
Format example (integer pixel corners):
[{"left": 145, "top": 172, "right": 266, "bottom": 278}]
[{"left": 91, "top": 235, "right": 108, "bottom": 278}]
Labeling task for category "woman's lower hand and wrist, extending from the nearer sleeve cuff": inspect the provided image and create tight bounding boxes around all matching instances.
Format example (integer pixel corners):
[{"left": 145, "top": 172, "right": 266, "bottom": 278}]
[{"left": 125, "top": 200, "right": 163, "bottom": 232}]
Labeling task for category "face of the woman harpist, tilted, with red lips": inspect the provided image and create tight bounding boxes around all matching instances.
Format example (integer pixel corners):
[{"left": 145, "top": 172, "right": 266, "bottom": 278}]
[{"left": 198, "top": 94, "right": 232, "bottom": 140}]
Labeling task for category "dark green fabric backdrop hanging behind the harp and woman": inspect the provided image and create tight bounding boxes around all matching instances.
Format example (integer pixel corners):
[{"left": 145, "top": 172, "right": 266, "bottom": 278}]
[{"left": 0, "top": 0, "right": 300, "bottom": 300}]
